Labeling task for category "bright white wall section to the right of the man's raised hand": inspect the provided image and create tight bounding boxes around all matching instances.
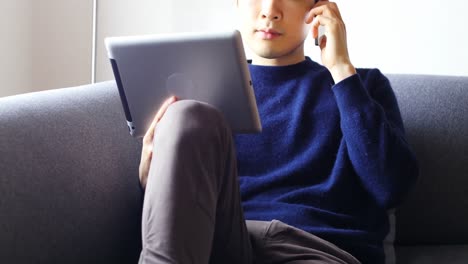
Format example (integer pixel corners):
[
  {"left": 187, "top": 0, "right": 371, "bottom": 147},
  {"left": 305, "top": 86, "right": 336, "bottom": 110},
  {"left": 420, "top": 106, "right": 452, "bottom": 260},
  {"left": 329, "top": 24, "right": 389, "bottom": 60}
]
[{"left": 330, "top": 0, "right": 468, "bottom": 76}]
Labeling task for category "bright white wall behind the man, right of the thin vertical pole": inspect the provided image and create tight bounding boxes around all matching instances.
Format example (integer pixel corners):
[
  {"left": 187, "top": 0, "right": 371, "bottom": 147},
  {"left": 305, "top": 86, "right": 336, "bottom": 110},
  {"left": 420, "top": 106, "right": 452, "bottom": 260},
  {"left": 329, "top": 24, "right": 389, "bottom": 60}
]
[{"left": 98, "top": 0, "right": 468, "bottom": 80}]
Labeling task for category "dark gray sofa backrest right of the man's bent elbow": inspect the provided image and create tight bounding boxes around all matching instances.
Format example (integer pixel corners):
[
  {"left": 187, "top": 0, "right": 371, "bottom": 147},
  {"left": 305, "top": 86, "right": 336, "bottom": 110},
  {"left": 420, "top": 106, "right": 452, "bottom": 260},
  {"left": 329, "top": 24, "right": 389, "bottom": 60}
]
[{"left": 388, "top": 75, "right": 468, "bottom": 245}]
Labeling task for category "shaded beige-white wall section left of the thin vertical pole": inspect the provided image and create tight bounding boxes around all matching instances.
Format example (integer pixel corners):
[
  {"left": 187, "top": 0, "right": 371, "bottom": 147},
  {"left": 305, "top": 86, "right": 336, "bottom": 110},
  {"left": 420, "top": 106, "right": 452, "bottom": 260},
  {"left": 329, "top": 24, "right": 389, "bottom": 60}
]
[{"left": 0, "top": 0, "right": 92, "bottom": 97}]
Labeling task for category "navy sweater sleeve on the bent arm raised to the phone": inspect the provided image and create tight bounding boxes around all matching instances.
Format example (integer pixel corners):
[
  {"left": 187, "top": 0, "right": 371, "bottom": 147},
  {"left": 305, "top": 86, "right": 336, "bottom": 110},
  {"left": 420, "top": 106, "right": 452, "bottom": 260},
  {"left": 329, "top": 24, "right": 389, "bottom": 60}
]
[{"left": 332, "top": 70, "right": 419, "bottom": 209}]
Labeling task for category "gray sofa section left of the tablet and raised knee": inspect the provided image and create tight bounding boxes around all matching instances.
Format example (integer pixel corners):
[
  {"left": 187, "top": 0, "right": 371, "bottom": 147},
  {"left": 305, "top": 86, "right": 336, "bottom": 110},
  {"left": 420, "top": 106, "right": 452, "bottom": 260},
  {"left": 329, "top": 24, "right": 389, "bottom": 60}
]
[{"left": 0, "top": 82, "right": 142, "bottom": 264}]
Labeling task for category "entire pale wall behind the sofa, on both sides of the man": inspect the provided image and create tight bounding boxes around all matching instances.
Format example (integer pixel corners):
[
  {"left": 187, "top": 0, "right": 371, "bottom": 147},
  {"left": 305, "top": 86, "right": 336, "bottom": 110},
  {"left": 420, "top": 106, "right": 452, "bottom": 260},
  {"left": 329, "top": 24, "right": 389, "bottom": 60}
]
[{"left": 0, "top": 0, "right": 468, "bottom": 96}]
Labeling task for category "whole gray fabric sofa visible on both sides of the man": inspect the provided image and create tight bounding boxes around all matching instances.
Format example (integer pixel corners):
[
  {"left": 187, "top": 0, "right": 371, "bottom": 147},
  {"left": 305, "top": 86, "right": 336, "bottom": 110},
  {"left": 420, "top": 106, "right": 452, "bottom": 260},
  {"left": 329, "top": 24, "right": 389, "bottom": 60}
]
[{"left": 0, "top": 75, "right": 468, "bottom": 264}]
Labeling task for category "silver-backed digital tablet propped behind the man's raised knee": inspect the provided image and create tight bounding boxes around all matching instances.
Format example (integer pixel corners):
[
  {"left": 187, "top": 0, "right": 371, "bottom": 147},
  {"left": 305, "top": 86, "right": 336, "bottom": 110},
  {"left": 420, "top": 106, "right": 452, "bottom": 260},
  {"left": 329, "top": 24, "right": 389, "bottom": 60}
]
[{"left": 105, "top": 30, "right": 262, "bottom": 137}]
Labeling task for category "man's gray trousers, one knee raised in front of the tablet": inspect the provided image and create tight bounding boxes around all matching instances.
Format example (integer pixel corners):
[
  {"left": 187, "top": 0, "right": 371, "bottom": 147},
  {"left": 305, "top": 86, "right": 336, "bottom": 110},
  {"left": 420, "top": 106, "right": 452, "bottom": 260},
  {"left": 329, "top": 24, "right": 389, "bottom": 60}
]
[{"left": 139, "top": 100, "right": 359, "bottom": 264}]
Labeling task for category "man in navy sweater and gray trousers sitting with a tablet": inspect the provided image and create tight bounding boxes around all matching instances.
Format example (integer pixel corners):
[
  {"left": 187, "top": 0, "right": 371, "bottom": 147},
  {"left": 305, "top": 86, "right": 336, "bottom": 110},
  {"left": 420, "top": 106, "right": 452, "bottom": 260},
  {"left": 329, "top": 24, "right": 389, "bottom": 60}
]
[{"left": 136, "top": 0, "right": 418, "bottom": 263}]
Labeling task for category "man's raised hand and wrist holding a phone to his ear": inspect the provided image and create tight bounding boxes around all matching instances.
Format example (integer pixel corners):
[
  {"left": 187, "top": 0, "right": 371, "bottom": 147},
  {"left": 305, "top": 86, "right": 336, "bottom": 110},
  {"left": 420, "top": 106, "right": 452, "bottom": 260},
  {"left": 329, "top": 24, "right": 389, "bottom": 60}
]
[{"left": 306, "top": 0, "right": 356, "bottom": 83}]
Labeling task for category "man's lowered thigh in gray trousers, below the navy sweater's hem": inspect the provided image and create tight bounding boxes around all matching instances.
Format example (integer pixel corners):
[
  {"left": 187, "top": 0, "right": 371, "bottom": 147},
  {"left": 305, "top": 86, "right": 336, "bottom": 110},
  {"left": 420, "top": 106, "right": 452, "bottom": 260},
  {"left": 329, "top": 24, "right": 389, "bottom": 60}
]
[{"left": 247, "top": 220, "right": 360, "bottom": 264}]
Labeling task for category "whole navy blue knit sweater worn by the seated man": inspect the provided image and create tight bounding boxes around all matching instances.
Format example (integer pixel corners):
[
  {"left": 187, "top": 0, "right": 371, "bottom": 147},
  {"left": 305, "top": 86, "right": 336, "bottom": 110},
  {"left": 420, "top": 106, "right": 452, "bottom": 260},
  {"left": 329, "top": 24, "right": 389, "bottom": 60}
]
[{"left": 235, "top": 58, "right": 418, "bottom": 263}]
